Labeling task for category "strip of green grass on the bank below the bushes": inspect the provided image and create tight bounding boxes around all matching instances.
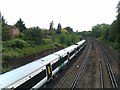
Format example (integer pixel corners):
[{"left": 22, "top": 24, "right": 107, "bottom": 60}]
[{"left": 2, "top": 44, "right": 56, "bottom": 61}]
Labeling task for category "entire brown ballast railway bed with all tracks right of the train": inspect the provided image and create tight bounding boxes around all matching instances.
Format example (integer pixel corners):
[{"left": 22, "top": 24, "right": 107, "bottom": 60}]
[{"left": 45, "top": 39, "right": 119, "bottom": 90}]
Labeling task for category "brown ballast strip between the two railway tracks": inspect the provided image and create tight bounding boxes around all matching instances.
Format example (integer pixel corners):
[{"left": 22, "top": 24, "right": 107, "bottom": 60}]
[{"left": 75, "top": 41, "right": 103, "bottom": 88}]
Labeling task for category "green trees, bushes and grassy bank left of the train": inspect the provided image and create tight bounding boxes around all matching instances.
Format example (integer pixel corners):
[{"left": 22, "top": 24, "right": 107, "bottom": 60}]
[{"left": 2, "top": 16, "right": 80, "bottom": 61}]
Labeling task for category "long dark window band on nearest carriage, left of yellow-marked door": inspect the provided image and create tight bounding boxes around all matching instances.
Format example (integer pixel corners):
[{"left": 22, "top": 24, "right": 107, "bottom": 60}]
[{"left": 16, "top": 70, "right": 46, "bottom": 89}]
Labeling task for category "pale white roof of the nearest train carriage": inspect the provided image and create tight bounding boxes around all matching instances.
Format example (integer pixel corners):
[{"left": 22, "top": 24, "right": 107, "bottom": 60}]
[{"left": 0, "top": 54, "right": 59, "bottom": 88}]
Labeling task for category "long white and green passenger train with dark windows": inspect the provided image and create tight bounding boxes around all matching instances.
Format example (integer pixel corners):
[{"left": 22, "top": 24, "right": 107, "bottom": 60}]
[{"left": 0, "top": 40, "right": 86, "bottom": 89}]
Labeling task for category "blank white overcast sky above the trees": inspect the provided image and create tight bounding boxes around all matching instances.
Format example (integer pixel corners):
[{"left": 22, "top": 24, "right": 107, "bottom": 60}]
[{"left": 0, "top": 0, "right": 119, "bottom": 31}]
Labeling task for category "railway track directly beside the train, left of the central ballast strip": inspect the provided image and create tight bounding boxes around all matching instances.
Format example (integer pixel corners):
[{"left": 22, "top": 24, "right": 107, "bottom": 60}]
[{"left": 46, "top": 38, "right": 91, "bottom": 88}]
